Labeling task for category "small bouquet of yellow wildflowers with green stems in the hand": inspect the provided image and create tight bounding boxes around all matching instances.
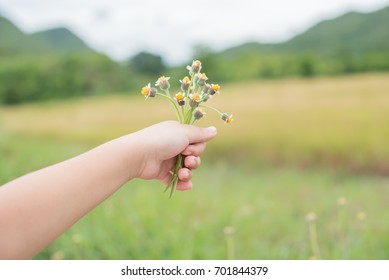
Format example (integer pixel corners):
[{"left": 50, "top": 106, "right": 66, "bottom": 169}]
[{"left": 141, "top": 60, "right": 232, "bottom": 197}]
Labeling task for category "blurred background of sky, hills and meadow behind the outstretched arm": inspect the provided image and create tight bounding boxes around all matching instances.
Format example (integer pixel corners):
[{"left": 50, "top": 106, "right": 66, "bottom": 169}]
[{"left": 0, "top": 0, "right": 389, "bottom": 259}]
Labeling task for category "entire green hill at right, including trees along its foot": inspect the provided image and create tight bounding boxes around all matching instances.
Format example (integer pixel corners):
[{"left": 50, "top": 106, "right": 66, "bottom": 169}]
[{"left": 197, "top": 7, "right": 389, "bottom": 81}]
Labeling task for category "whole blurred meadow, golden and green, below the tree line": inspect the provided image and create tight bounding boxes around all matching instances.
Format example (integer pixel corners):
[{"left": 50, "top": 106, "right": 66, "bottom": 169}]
[{"left": 0, "top": 73, "right": 389, "bottom": 259}]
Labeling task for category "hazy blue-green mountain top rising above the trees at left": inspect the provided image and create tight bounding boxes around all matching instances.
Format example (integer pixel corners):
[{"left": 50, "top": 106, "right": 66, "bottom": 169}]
[{"left": 0, "top": 16, "right": 93, "bottom": 56}]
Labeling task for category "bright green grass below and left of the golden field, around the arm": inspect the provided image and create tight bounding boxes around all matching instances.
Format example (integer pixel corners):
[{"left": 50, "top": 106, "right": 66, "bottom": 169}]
[{"left": 0, "top": 132, "right": 389, "bottom": 259}]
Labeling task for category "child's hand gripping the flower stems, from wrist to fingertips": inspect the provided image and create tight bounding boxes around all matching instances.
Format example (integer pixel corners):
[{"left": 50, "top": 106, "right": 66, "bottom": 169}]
[{"left": 136, "top": 121, "right": 217, "bottom": 190}]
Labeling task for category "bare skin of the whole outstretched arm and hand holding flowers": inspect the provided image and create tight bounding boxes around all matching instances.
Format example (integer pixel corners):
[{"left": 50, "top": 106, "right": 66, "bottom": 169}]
[{"left": 0, "top": 121, "right": 217, "bottom": 259}]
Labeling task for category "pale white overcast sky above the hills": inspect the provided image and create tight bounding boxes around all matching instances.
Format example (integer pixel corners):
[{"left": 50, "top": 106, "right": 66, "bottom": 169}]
[{"left": 0, "top": 0, "right": 389, "bottom": 64}]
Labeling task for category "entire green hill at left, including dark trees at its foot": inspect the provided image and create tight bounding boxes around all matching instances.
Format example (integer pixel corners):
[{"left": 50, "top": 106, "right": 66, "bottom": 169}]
[{"left": 0, "top": 14, "right": 138, "bottom": 104}]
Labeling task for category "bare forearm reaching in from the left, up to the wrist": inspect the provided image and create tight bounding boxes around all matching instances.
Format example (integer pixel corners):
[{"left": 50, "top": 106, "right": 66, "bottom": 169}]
[{"left": 0, "top": 135, "right": 142, "bottom": 258}]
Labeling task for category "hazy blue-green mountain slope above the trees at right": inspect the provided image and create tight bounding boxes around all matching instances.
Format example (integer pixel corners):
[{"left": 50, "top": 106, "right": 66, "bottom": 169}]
[{"left": 221, "top": 7, "right": 389, "bottom": 56}]
